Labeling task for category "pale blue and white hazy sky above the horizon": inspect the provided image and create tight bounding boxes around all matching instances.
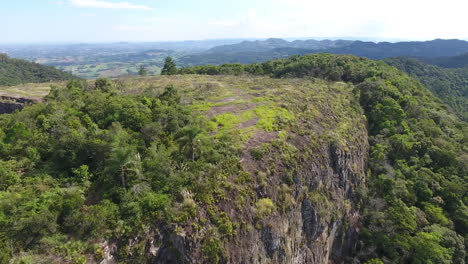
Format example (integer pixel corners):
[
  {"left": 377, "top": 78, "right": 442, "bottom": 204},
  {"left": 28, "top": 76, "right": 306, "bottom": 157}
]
[{"left": 0, "top": 0, "right": 468, "bottom": 43}]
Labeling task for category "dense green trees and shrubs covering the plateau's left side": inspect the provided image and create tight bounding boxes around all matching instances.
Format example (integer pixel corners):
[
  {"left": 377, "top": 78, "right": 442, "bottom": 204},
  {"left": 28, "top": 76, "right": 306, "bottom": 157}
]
[{"left": 0, "top": 79, "right": 239, "bottom": 263}]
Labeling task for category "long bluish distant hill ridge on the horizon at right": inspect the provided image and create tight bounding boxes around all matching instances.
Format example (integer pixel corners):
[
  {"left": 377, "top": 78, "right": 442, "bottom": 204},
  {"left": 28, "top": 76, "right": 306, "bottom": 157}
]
[{"left": 179, "top": 39, "right": 468, "bottom": 66}]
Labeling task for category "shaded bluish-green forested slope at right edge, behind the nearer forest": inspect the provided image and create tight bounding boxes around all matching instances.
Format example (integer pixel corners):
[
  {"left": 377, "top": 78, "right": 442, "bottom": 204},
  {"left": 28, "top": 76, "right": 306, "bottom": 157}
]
[{"left": 384, "top": 57, "right": 468, "bottom": 121}]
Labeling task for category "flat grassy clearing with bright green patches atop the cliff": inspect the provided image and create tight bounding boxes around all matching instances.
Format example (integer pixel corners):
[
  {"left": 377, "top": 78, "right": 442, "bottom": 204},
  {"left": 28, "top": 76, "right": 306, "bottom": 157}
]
[{"left": 107, "top": 75, "right": 364, "bottom": 149}]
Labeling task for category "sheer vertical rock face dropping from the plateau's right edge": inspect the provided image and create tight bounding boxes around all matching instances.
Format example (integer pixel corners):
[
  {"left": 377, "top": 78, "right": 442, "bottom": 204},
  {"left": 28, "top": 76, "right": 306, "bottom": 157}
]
[{"left": 224, "top": 135, "right": 368, "bottom": 264}]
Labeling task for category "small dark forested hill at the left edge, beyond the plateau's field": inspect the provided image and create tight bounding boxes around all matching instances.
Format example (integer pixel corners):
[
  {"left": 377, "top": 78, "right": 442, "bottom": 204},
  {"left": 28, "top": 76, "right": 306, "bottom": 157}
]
[{"left": 0, "top": 54, "right": 76, "bottom": 86}]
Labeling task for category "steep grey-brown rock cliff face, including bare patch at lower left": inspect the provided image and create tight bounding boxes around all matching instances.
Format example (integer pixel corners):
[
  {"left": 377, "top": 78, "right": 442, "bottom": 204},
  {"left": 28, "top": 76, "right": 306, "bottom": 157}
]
[{"left": 147, "top": 130, "right": 368, "bottom": 264}]
